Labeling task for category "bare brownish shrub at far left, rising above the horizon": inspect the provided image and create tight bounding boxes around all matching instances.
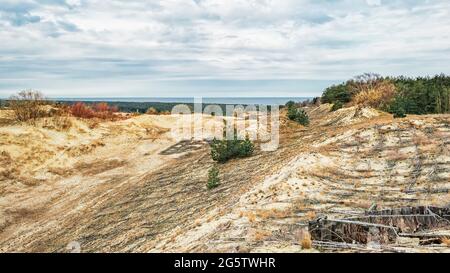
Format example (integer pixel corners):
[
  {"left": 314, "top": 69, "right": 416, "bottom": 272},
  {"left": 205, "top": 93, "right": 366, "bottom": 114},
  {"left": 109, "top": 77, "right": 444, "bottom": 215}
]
[{"left": 9, "top": 90, "right": 49, "bottom": 122}]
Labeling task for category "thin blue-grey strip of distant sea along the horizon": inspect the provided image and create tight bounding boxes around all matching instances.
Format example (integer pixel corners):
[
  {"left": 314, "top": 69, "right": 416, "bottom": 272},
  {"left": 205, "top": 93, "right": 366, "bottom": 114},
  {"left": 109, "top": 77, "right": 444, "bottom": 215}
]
[{"left": 51, "top": 97, "right": 312, "bottom": 105}]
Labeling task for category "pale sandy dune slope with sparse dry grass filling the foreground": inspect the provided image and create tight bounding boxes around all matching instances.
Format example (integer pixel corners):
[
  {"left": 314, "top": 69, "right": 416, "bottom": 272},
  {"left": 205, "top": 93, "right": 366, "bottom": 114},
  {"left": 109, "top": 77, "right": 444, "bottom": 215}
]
[{"left": 0, "top": 105, "right": 450, "bottom": 252}]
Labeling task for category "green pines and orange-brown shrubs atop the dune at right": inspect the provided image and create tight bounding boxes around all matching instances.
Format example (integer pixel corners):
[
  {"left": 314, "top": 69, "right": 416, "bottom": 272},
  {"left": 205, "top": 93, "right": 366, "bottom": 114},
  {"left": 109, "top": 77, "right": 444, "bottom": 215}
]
[{"left": 321, "top": 73, "right": 450, "bottom": 117}]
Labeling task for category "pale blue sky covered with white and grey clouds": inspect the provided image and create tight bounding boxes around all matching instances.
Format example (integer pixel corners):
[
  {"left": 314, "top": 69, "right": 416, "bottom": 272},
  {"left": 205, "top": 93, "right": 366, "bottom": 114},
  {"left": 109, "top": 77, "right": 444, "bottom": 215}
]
[{"left": 0, "top": 0, "right": 450, "bottom": 97}]
